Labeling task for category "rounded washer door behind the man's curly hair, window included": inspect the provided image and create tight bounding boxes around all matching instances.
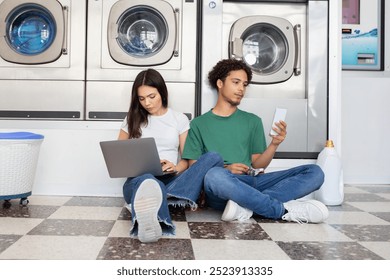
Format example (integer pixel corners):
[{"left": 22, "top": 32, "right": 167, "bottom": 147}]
[{"left": 229, "top": 16, "right": 296, "bottom": 84}]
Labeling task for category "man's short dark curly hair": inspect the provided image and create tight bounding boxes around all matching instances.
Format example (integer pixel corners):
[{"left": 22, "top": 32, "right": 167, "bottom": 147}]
[{"left": 208, "top": 59, "right": 252, "bottom": 89}]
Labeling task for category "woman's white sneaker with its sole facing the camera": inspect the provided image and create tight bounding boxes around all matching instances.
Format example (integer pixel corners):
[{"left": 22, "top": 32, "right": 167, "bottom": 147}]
[{"left": 134, "top": 179, "right": 162, "bottom": 243}]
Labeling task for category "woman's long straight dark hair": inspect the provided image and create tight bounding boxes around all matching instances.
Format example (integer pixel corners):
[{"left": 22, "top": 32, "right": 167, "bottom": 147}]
[{"left": 127, "top": 69, "right": 168, "bottom": 138}]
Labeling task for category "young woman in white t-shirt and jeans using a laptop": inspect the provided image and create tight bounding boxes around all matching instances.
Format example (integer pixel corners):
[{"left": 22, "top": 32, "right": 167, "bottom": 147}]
[{"left": 118, "top": 69, "right": 223, "bottom": 242}]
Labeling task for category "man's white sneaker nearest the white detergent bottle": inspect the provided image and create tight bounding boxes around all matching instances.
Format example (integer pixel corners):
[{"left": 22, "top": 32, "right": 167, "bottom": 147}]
[{"left": 282, "top": 199, "right": 329, "bottom": 224}]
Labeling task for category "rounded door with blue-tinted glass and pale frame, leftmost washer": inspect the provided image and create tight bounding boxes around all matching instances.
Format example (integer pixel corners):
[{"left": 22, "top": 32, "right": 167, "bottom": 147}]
[{"left": 0, "top": 0, "right": 65, "bottom": 64}]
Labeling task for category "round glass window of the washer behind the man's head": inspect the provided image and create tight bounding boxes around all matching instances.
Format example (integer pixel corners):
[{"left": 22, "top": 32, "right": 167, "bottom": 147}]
[{"left": 242, "top": 23, "right": 288, "bottom": 75}]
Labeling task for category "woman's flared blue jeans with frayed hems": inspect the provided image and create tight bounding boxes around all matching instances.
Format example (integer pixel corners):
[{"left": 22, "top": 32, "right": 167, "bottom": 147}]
[{"left": 123, "top": 152, "right": 223, "bottom": 236}]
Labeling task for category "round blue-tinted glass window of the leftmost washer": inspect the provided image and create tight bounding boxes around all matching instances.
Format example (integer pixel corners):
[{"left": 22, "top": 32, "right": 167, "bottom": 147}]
[{"left": 6, "top": 4, "right": 57, "bottom": 55}]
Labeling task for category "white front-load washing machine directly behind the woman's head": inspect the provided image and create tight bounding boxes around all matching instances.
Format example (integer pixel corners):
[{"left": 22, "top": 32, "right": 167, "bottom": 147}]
[{"left": 86, "top": 0, "right": 199, "bottom": 120}]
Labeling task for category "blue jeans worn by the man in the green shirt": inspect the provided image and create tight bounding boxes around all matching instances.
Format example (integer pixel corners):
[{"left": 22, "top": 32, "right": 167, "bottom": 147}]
[{"left": 204, "top": 164, "right": 324, "bottom": 219}]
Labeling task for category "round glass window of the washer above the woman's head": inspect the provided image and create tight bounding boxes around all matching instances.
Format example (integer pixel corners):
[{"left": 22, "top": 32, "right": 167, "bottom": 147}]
[{"left": 117, "top": 6, "right": 169, "bottom": 57}]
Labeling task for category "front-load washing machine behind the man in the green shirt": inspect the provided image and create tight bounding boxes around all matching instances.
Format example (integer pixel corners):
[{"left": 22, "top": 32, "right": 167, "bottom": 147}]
[{"left": 200, "top": 0, "right": 328, "bottom": 158}]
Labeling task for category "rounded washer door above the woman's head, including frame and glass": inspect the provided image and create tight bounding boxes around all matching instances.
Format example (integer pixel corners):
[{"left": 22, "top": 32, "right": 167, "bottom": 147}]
[{"left": 108, "top": 0, "right": 177, "bottom": 66}]
